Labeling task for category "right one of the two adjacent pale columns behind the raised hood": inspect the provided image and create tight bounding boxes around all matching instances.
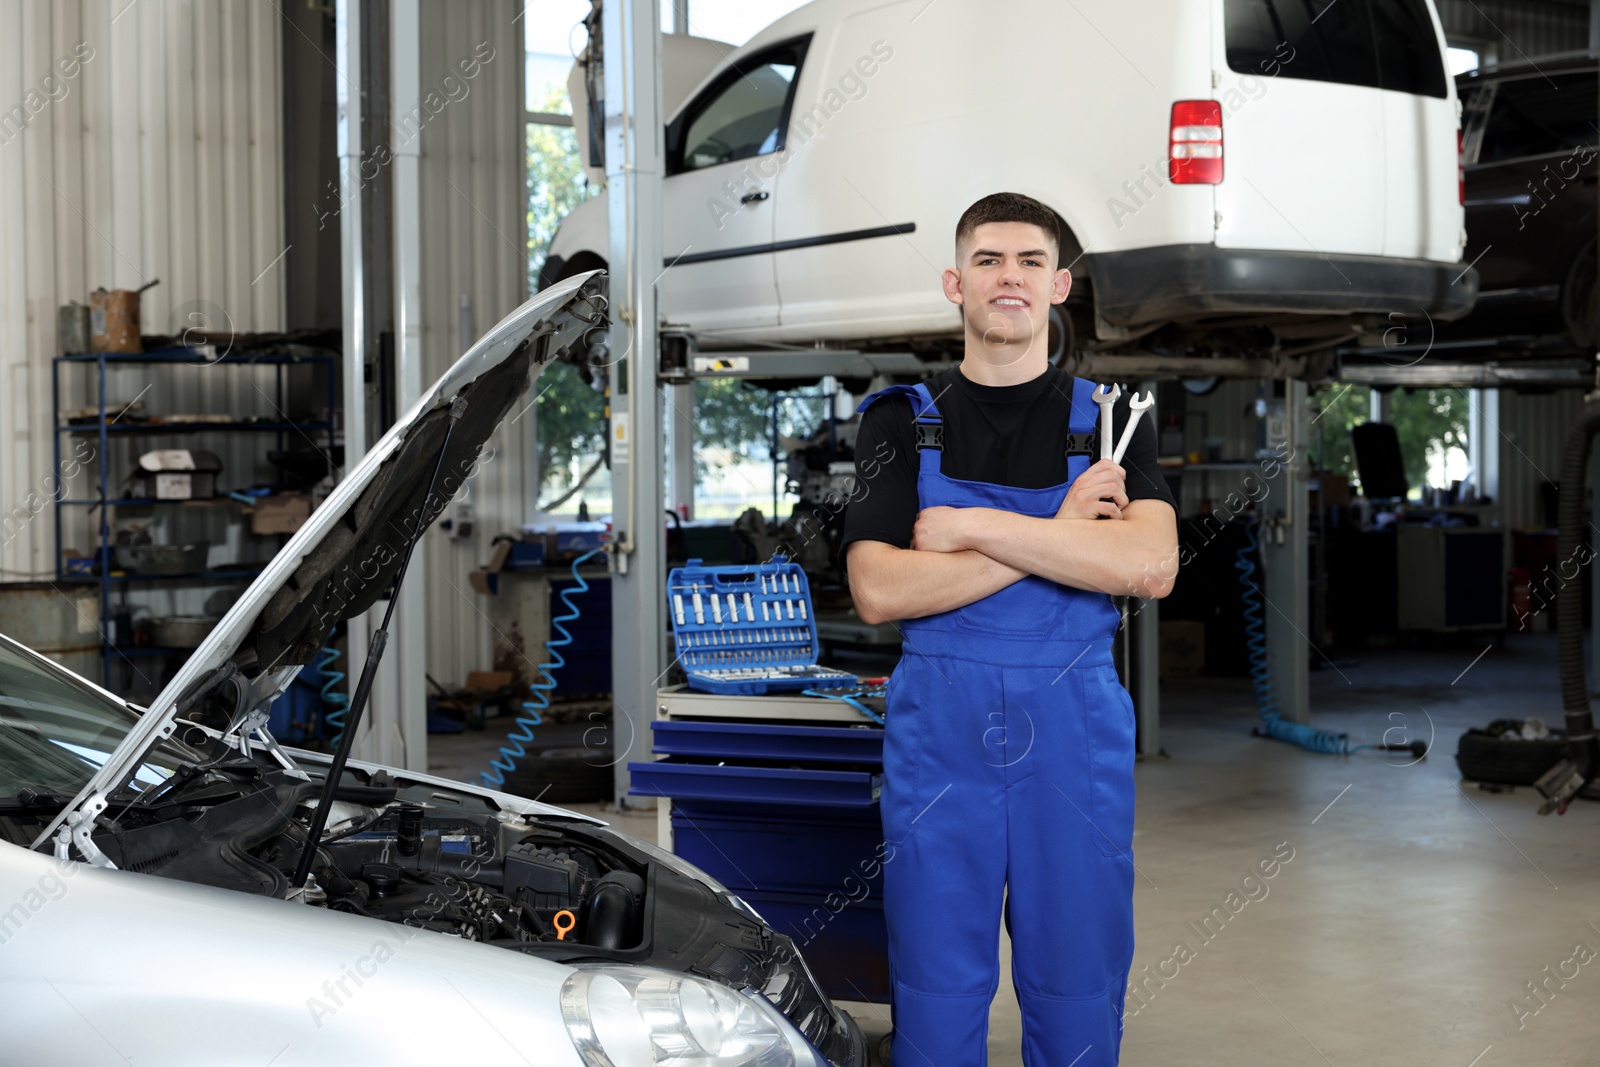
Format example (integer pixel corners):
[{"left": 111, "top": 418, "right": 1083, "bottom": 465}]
[{"left": 366, "top": 0, "right": 425, "bottom": 771}]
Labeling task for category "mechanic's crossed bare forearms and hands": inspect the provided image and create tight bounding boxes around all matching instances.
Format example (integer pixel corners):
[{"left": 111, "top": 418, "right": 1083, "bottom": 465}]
[{"left": 846, "top": 459, "right": 1178, "bottom": 622}]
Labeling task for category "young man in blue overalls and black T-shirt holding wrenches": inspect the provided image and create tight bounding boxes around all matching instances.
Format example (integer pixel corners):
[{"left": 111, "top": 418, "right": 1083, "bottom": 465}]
[{"left": 842, "top": 194, "right": 1178, "bottom": 1067}]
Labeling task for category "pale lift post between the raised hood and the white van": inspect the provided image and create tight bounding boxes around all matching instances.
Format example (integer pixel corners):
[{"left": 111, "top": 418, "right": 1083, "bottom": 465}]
[{"left": 602, "top": 0, "right": 666, "bottom": 808}]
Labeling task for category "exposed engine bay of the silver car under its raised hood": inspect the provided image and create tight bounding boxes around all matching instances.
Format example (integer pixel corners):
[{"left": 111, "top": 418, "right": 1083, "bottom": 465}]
[{"left": 37, "top": 749, "right": 853, "bottom": 1062}]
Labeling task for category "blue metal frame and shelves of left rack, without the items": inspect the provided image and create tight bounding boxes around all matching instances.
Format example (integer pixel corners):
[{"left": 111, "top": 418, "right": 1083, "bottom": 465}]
[{"left": 50, "top": 347, "right": 336, "bottom": 688}]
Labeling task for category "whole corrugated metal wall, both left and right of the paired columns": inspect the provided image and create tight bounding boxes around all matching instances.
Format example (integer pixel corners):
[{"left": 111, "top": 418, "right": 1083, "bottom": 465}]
[{"left": 0, "top": 0, "right": 534, "bottom": 681}]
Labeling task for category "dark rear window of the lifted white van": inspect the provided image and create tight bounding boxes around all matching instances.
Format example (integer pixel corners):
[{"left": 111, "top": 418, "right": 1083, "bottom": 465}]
[{"left": 1222, "top": 0, "right": 1445, "bottom": 98}]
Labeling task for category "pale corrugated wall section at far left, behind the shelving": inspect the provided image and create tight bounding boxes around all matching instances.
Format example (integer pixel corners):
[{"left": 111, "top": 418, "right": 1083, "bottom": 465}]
[{"left": 0, "top": 0, "right": 285, "bottom": 581}]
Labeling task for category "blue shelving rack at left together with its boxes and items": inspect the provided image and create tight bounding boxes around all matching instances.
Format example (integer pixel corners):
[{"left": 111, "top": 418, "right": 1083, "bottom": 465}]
[{"left": 51, "top": 347, "right": 339, "bottom": 686}]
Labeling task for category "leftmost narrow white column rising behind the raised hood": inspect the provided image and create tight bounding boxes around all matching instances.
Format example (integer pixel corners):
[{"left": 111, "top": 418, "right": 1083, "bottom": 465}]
[{"left": 334, "top": 0, "right": 373, "bottom": 751}]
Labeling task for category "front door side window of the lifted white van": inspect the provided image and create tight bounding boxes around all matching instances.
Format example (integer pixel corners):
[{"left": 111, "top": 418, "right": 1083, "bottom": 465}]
[{"left": 667, "top": 42, "right": 805, "bottom": 174}]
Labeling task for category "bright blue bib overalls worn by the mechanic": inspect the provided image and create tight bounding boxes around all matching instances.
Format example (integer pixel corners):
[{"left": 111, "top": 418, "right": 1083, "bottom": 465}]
[{"left": 856, "top": 379, "right": 1134, "bottom": 1067}]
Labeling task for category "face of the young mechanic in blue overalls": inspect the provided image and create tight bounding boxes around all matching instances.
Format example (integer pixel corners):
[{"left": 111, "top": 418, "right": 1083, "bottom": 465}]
[{"left": 944, "top": 222, "right": 1072, "bottom": 358}]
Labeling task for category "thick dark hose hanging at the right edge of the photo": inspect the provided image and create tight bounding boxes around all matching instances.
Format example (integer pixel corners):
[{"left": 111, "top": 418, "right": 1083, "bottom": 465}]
[{"left": 1555, "top": 400, "right": 1600, "bottom": 782}]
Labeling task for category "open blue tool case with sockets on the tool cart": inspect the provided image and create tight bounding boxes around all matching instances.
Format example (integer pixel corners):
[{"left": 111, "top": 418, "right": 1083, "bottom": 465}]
[{"left": 667, "top": 555, "right": 856, "bottom": 696}]
